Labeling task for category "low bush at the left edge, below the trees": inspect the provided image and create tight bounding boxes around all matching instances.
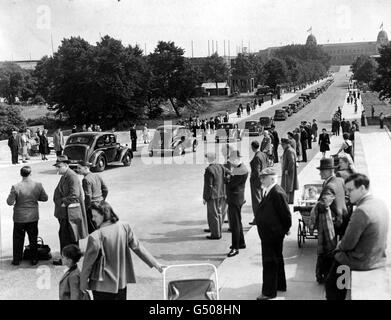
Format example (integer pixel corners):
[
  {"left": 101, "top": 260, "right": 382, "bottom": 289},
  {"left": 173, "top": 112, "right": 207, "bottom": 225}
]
[{"left": 0, "top": 104, "right": 26, "bottom": 140}]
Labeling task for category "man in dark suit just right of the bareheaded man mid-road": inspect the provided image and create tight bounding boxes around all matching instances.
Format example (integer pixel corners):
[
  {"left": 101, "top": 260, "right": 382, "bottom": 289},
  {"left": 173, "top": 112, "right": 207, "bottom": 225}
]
[{"left": 226, "top": 150, "right": 248, "bottom": 257}]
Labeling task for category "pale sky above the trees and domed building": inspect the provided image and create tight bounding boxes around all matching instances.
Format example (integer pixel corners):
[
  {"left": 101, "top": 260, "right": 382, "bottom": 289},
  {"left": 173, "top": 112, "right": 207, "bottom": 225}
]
[{"left": 0, "top": 0, "right": 391, "bottom": 61}]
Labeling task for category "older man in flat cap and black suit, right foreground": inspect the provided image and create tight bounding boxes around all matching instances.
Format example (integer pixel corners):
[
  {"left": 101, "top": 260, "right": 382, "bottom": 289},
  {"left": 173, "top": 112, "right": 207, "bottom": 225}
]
[{"left": 256, "top": 168, "right": 292, "bottom": 300}]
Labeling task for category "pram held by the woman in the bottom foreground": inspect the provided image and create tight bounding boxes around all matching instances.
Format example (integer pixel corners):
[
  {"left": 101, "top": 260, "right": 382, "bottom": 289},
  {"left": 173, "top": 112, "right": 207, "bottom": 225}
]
[{"left": 163, "top": 263, "right": 219, "bottom": 300}]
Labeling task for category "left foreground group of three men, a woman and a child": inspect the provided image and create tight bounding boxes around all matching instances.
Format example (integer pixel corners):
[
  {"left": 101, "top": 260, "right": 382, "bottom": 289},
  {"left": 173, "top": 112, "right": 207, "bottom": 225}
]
[{"left": 7, "top": 155, "right": 163, "bottom": 300}]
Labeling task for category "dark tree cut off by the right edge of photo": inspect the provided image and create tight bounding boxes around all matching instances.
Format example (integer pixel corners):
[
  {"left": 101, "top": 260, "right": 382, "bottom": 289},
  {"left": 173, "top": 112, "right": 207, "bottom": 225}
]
[{"left": 372, "top": 45, "right": 391, "bottom": 99}]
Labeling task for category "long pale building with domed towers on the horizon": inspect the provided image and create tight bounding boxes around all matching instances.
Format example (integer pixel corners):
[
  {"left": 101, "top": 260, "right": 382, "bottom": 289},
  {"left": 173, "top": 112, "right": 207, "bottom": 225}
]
[{"left": 259, "top": 30, "right": 389, "bottom": 65}]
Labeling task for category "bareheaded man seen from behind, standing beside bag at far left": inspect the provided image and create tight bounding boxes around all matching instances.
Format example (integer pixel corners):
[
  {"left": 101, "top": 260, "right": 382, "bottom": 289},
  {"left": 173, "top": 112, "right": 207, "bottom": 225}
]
[{"left": 7, "top": 166, "right": 48, "bottom": 266}]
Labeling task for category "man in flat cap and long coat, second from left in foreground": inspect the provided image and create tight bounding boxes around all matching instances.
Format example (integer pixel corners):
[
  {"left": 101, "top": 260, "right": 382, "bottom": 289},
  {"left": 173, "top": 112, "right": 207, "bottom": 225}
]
[{"left": 53, "top": 155, "right": 88, "bottom": 265}]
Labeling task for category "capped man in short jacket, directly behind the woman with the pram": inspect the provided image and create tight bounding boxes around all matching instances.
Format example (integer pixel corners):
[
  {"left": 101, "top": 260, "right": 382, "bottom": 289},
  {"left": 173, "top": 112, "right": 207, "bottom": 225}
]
[{"left": 77, "top": 161, "right": 109, "bottom": 233}]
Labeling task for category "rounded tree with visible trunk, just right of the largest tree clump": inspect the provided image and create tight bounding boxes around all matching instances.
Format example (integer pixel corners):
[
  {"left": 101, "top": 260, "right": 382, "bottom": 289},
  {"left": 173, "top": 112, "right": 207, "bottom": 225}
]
[{"left": 148, "top": 41, "right": 201, "bottom": 117}]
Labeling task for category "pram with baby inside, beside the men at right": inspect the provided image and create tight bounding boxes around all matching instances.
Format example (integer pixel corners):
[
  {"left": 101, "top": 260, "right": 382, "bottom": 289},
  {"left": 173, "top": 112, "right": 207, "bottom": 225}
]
[{"left": 293, "top": 183, "right": 322, "bottom": 248}]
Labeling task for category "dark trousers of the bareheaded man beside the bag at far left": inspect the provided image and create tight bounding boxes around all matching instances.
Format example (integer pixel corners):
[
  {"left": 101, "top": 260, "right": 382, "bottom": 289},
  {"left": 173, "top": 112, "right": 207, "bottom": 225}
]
[{"left": 13, "top": 221, "right": 38, "bottom": 262}]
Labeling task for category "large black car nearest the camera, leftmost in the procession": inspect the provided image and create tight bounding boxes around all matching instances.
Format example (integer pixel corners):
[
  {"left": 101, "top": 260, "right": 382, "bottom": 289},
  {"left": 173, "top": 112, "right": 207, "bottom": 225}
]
[{"left": 64, "top": 132, "right": 133, "bottom": 172}]
